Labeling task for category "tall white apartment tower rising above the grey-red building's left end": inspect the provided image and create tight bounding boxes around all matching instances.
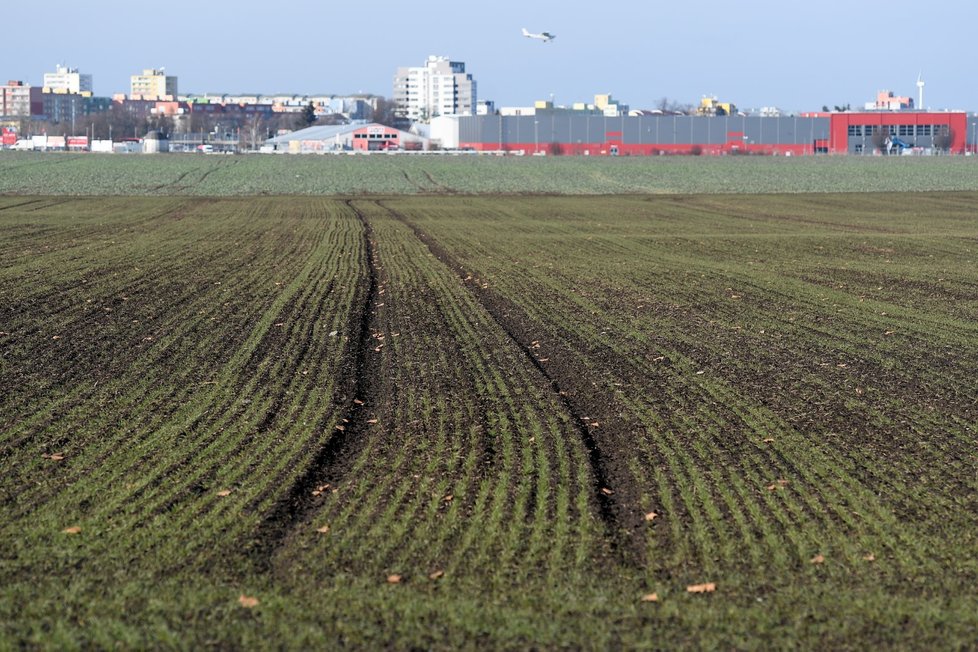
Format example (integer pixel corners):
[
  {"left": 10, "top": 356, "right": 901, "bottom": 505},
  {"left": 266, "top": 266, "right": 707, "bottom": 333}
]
[{"left": 394, "top": 55, "right": 477, "bottom": 122}]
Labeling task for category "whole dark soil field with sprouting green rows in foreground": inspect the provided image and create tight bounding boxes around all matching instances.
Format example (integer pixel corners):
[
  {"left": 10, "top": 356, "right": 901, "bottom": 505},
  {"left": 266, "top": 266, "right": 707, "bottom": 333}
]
[{"left": 0, "top": 193, "right": 978, "bottom": 649}]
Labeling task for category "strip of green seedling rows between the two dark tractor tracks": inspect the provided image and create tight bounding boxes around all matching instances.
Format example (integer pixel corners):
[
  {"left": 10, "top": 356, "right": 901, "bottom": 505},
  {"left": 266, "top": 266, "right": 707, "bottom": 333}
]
[{"left": 279, "top": 202, "right": 601, "bottom": 586}]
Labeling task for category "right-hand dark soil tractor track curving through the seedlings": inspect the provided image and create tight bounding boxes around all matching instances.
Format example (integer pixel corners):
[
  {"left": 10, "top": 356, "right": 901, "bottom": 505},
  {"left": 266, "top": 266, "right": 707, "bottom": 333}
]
[{"left": 377, "top": 202, "right": 645, "bottom": 565}]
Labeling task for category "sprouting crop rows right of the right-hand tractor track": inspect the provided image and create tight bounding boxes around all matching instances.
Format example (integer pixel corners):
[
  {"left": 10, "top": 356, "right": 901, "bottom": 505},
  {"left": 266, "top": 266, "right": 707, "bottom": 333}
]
[{"left": 388, "top": 195, "right": 978, "bottom": 620}]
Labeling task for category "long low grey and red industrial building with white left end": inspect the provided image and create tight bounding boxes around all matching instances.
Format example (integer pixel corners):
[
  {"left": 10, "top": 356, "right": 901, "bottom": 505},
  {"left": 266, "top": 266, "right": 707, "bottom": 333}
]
[{"left": 431, "top": 109, "right": 978, "bottom": 156}]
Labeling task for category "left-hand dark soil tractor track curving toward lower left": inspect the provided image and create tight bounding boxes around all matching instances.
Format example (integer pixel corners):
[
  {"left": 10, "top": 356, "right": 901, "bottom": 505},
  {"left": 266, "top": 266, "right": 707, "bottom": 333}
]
[{"left": 248, "top": 200, "right": 382, "bottom": 571}]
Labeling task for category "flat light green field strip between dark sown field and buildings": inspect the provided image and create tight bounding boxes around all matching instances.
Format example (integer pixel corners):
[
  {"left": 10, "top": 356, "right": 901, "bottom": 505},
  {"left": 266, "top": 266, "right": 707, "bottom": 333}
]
[{"left": 0, "top": 151, "right": 978, "bottom": 197}]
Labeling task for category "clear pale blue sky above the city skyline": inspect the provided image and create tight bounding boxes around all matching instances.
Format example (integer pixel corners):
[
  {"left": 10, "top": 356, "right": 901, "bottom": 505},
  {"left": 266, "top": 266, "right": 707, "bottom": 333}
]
[{"left": 0, "top": 0, "right": 978, "bottom": 110}]
